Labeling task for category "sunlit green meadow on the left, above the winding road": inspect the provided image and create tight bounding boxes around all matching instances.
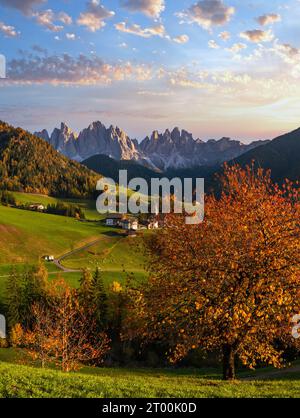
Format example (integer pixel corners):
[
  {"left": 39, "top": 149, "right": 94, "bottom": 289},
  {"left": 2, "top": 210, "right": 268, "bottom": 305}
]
[{"left": 0, "top": 206, "right": 104, "bottom": 264}]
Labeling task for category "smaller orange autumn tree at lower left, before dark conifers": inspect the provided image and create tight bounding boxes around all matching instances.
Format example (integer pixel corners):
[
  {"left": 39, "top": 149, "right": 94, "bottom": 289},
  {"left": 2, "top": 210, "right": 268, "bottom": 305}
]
[{"left": 20, "top": 280, "right": 109, "bottom": 372}]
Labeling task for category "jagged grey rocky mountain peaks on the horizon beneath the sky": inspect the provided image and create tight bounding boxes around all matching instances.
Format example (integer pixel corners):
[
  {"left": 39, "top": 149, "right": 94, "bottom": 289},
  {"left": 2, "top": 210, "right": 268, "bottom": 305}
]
[{"left": 35, "top": 122, "right": 268, "bottom": 171}]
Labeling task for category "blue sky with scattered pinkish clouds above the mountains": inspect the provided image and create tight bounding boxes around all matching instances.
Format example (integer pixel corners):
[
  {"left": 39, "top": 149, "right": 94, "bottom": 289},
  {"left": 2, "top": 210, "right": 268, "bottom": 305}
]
[{"left": 0, "top": 0, "right": 300, "bottom": 142}]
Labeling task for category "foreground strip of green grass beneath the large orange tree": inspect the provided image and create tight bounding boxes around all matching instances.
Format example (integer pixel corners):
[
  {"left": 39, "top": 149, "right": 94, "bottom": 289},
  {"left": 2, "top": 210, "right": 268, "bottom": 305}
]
[{"left": 0, "top": 349, "right": 300, "bottom": 398}]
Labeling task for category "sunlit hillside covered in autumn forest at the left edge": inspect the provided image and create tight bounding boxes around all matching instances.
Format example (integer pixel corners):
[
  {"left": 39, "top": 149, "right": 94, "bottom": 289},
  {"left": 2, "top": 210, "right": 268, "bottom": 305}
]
[{"left": 0, "top": 121, "right": 99, "bottom": 197}]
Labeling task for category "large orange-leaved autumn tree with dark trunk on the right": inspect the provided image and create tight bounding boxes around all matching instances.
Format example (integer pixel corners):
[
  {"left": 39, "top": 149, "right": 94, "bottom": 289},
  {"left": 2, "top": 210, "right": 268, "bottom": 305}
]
[{"left": 127, "top": 166, "right": 300, "bottom": 380}]
